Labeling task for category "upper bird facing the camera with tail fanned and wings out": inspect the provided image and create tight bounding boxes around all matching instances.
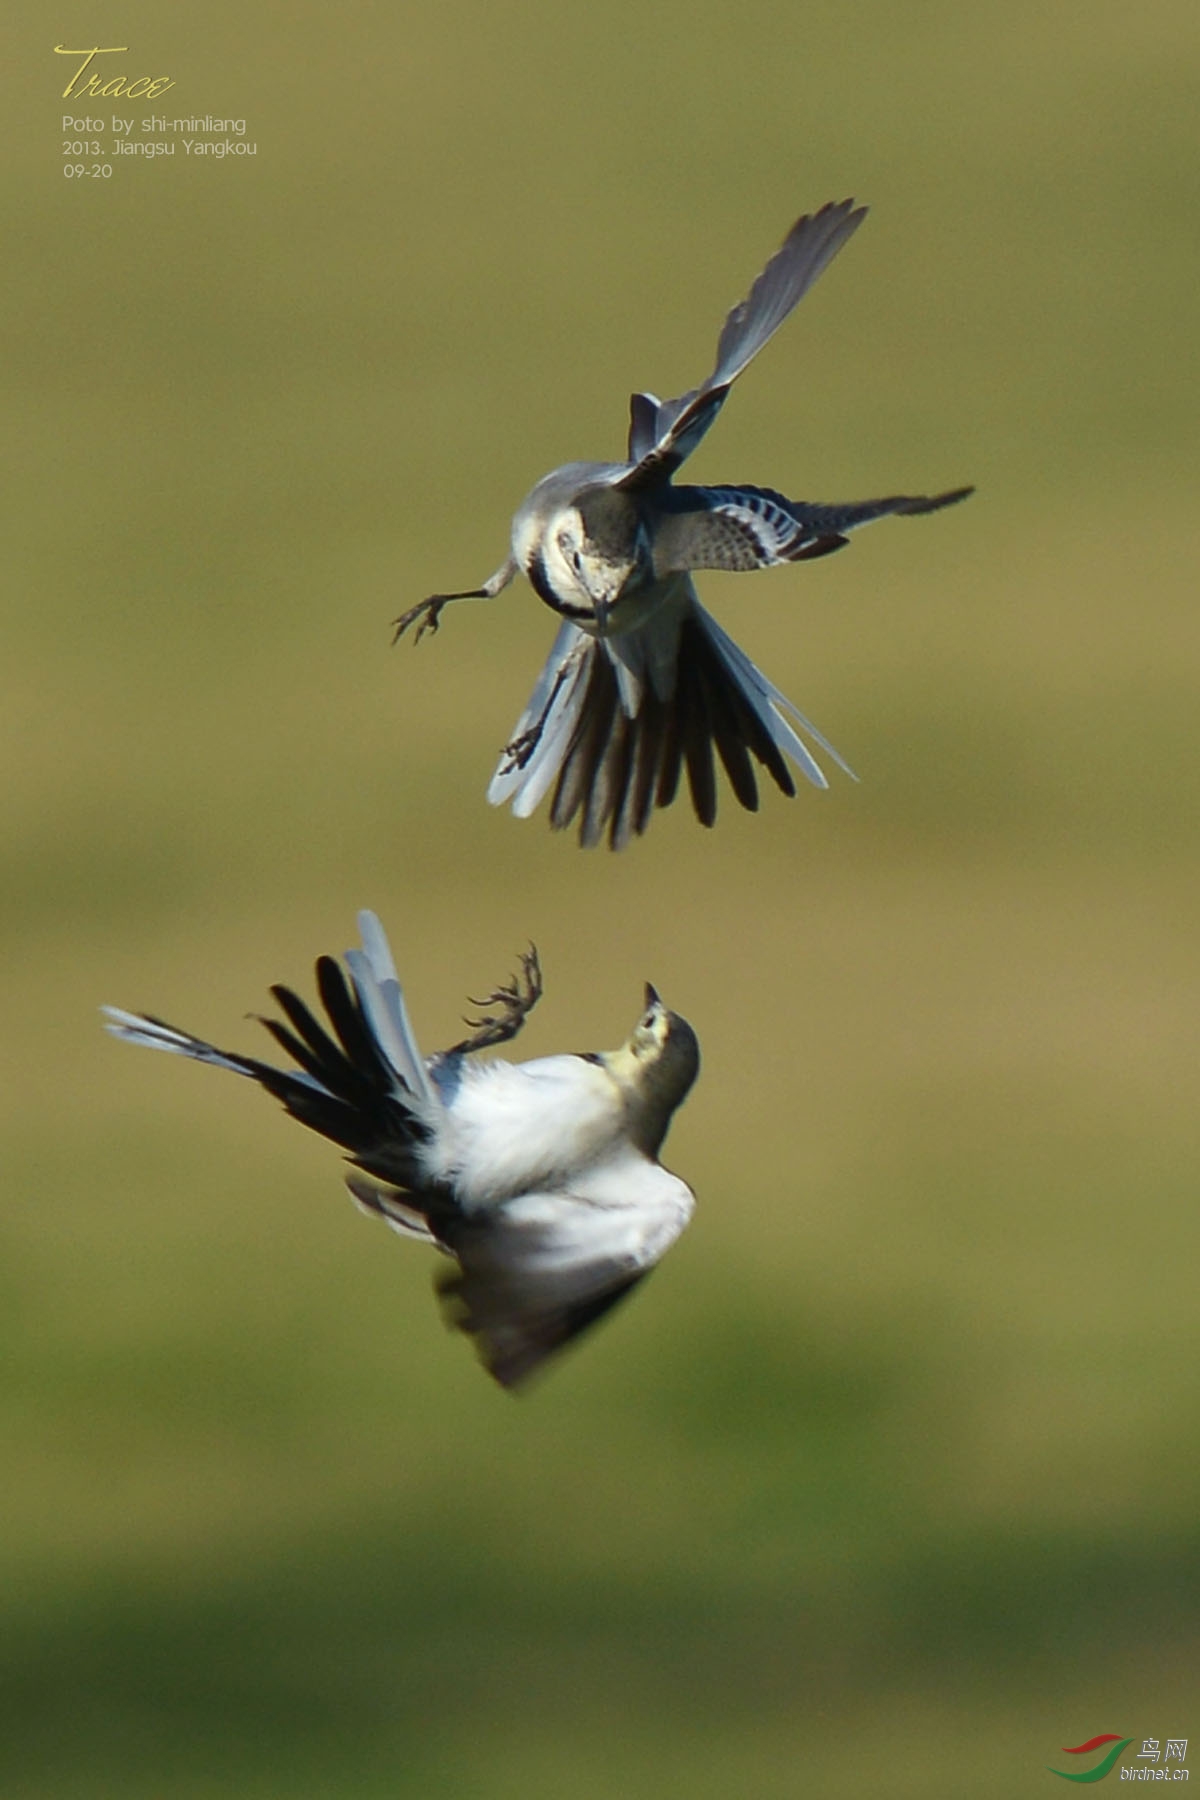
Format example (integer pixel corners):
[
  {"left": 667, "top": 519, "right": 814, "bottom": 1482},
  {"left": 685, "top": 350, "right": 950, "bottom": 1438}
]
[{"left": 396, "top": 200, "right": 973, "bottom": 850}]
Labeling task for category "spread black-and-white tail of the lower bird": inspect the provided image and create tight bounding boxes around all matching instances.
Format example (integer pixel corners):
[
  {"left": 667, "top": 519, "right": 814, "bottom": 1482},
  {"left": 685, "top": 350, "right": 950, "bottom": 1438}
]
[{"left": 103, "top": 913, "right": 443, "bottom": 1184}]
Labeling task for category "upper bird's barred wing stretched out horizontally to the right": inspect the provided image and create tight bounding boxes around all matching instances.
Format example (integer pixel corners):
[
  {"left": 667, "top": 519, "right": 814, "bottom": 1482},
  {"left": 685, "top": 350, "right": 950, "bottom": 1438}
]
[{"left": 653, "top": 488, "right": 973, "bottom": 578}]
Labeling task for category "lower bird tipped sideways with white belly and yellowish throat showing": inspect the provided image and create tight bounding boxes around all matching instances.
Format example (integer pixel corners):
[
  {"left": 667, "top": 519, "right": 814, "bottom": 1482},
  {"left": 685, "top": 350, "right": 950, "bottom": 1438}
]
[{"left": 101, "top": 913, "right": 700, "bottom": 1388}]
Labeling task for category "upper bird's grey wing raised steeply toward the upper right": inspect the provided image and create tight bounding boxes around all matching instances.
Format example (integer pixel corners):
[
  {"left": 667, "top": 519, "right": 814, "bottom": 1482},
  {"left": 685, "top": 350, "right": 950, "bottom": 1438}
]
[{"left": 617, "top": 200, "right": 867, "bottom": 488}]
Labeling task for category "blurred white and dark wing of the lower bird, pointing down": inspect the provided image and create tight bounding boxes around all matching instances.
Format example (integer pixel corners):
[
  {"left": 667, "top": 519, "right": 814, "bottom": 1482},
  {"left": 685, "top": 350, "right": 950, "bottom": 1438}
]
[{"left": 437, "top": 1147, "right": 694, "bottom": 1388}]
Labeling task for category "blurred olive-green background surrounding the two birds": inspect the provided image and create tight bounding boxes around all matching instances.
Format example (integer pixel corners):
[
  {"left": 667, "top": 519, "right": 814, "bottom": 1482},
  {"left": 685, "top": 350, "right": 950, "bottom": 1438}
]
[{"left": 0, "top": 0, "right": 1200, "bottom": 1800}]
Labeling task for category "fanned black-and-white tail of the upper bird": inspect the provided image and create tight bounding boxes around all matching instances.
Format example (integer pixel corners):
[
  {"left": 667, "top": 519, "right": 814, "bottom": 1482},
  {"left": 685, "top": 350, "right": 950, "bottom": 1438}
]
[{"left": 488, "top": 576, "right": 849, "bottom": 850}]
